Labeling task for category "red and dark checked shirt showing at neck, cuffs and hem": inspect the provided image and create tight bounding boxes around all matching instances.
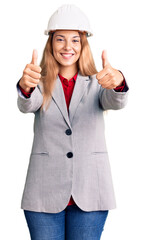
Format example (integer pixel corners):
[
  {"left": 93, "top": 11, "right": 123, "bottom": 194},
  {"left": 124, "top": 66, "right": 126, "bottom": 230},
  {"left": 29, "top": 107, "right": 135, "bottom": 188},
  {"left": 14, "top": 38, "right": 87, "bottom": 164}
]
[{"left": 19, "top": 73, "right": 126, "bottom": 205}]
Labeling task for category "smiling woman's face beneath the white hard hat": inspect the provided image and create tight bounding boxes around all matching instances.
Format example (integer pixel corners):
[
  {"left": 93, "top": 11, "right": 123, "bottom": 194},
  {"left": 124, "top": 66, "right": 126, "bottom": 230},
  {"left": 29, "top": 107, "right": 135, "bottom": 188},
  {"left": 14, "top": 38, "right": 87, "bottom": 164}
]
[{"left": 52, "top": 30, "right": 81, "bottom": 67}]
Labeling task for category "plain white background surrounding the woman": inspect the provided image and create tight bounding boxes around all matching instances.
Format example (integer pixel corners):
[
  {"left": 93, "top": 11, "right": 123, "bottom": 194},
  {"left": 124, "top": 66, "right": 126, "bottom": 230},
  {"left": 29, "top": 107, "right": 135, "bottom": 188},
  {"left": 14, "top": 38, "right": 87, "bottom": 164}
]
[{"left": 0, "top": 0, "right": 146, "bottom": 240}]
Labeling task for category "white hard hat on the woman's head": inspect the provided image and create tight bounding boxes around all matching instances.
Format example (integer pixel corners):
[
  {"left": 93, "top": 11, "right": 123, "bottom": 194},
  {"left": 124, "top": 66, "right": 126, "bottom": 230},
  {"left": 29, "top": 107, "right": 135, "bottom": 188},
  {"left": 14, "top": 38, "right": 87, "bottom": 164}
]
[{"left": 45, "top": 4, "right": 93, "bottom": 37}]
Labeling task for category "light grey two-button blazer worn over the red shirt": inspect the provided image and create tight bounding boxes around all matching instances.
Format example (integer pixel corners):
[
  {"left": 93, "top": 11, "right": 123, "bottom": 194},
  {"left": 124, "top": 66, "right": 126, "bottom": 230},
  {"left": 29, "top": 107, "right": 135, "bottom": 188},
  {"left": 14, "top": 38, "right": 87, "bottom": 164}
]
[{"left": 18, "top": 74, "right": 128, "bottom": 213}]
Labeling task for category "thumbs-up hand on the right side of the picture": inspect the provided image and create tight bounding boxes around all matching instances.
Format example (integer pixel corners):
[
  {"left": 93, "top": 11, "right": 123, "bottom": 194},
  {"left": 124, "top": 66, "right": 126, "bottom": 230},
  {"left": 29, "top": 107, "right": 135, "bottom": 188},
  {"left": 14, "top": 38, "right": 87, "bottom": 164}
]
[{"left": 96, "top": 50, "right": 124, "bottom": 89}]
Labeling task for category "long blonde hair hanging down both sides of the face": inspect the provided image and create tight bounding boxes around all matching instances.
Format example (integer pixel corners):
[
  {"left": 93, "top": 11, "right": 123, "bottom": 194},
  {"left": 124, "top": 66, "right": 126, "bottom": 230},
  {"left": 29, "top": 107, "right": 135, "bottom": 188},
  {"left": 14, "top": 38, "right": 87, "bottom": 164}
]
[{"left": 40, "top": 33, "right": 97, "bottom": 108}]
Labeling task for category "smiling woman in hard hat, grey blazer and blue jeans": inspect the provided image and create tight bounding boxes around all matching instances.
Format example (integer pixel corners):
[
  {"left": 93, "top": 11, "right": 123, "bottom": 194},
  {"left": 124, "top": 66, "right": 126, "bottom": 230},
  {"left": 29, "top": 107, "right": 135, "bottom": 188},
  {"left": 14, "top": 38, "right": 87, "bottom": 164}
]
[{"left": 17, "top": 5, "right": 128, "bottom": 240}]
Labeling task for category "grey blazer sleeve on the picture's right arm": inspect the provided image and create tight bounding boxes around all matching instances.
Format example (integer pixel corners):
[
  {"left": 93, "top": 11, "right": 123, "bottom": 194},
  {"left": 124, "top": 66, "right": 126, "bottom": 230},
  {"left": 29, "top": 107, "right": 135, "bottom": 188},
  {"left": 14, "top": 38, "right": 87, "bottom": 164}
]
[{"left": 99, "top": 83, "right": 129, "bottom": 110}]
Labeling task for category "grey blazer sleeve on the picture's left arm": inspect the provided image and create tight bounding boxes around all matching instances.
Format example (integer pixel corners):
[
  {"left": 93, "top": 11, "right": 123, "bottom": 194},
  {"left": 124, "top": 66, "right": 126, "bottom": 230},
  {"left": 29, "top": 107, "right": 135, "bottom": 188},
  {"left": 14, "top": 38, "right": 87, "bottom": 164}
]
[{"left": 17, "top": 85, "right": 43, "bottom": 113}]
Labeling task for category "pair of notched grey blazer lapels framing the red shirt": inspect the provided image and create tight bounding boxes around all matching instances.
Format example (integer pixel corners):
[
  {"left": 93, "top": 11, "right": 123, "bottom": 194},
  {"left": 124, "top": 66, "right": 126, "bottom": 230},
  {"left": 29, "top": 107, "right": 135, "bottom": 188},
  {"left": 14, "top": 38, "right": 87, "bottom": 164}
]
[{"left": 52, "top": 73, "right": 90, "bottom": 128}]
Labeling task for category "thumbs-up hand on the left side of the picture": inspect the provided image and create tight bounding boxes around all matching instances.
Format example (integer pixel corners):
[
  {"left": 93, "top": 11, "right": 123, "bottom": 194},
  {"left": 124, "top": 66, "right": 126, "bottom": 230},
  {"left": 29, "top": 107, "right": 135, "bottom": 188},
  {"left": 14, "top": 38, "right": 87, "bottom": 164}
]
[{"left": 19, "top": 50, "right": 41, "bottom": 92}]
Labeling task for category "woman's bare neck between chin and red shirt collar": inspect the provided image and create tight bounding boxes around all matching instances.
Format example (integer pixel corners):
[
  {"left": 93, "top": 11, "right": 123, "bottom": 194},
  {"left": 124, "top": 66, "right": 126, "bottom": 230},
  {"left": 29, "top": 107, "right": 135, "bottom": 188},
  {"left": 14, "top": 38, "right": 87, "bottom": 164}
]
[{"left": 59, "top": 65, "right": 78, "bottom": 80}]
